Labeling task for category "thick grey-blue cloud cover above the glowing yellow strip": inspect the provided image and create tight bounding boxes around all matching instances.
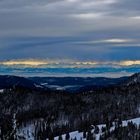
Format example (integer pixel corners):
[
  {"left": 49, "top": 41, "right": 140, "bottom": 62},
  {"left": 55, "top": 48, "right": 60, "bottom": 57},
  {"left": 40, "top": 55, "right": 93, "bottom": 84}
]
[{"left": 0, "top": 0, "right": 140, "bottom": 66}]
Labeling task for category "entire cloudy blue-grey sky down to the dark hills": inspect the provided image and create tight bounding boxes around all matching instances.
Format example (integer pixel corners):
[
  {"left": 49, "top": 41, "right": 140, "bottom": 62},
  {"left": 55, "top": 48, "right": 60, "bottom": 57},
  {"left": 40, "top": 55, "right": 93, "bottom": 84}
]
[{"left": 0, "top": 0, "right": 140, "bottom": 77}]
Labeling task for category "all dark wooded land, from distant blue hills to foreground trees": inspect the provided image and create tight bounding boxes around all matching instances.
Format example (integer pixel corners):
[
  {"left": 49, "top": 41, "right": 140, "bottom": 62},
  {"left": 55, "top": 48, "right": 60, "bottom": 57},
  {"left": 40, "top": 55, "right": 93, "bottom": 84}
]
[{"left": 0, "top": 73, "right": 140, "bottom": 140}]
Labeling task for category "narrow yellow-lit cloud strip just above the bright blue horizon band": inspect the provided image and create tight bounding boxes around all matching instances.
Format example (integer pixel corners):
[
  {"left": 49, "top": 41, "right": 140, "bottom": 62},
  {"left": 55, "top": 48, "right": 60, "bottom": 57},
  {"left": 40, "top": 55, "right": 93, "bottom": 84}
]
[{"left": 0, "top": 59, "right": 140, "bottom": 68}]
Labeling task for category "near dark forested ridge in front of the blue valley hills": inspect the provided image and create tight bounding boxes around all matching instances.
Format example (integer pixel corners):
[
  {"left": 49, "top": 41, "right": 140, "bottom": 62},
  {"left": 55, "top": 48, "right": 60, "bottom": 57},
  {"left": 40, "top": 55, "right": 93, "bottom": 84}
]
[{"left": 0, "top": 75, "right": 140, "bottom": 140}]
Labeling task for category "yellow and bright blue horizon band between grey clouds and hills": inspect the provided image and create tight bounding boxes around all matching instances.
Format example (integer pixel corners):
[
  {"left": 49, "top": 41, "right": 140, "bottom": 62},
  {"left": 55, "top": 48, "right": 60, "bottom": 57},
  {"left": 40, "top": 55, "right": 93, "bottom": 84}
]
[{"left": 0, "top": 60, "right": 140, "bottom": 77}]
